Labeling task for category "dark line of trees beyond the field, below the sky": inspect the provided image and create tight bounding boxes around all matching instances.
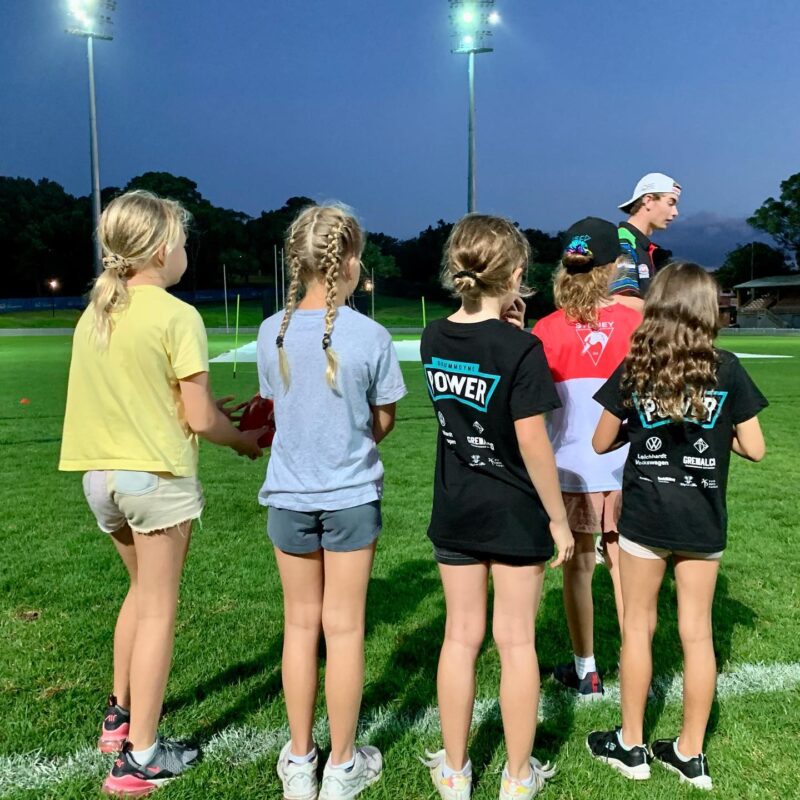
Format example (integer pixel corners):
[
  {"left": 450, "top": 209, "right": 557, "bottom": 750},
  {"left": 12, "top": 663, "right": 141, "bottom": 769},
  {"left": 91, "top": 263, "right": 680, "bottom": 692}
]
[{"left": 0, "top": 172, "right": 800, "bottom": 312}]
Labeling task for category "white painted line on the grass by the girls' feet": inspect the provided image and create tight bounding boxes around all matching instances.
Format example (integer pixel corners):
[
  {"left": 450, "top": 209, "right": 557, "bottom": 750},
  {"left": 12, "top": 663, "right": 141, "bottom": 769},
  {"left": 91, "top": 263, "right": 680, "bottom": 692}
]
[{"left": 0, "top": 662, "right": 800, "bottom": 797}]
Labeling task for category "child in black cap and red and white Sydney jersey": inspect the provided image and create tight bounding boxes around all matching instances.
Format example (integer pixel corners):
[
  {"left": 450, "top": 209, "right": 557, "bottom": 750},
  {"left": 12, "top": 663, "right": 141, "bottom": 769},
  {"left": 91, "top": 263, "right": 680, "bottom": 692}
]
[{"left": 533, "top": 217, "right": 641, "bottom": 699}]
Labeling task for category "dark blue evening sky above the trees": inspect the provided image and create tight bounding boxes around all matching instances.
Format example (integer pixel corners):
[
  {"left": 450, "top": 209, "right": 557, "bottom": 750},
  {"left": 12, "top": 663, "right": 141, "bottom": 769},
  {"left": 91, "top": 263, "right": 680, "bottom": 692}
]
[{"left": 0, "top": 0, "right": 800, "bottom": 263}]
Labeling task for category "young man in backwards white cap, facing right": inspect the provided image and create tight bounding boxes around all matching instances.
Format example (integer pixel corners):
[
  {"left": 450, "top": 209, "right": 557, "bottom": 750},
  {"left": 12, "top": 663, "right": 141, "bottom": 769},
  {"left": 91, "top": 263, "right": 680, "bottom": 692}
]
[{"left": 609, "top": 172, "right": 681, "bottom": 310}]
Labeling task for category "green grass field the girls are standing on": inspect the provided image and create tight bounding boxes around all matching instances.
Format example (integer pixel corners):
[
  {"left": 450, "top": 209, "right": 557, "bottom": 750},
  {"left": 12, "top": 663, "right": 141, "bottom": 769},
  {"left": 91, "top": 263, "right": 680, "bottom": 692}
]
[{"left": 0, "top": 336, "right": 800, "bottom": 800}]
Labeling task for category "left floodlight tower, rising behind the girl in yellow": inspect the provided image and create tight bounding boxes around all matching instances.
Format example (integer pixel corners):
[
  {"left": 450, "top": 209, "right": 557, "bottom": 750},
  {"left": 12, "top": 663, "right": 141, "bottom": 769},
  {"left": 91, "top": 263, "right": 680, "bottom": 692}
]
[{"left": 66, "top": 0, "right": 117, "bottom": 275}]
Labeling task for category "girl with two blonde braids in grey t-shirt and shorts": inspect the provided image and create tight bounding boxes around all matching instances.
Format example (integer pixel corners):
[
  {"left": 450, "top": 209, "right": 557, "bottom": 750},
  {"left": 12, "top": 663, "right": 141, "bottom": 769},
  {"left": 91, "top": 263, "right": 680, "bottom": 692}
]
[{"left": 258, "top": 206, "right": 406, "bottom": 800}]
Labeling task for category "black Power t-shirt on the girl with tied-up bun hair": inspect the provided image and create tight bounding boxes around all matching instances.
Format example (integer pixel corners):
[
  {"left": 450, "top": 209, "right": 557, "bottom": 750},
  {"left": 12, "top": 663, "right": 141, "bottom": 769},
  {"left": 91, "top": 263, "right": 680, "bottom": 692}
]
[{"left": 420, "top": 319, "right": 561, "bottom": 560}]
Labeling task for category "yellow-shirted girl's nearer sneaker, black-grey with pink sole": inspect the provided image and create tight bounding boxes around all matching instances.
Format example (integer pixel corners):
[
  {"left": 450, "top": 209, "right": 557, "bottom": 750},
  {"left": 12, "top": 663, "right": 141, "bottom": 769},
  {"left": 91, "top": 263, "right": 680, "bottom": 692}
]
[{"left": 103, "top": 737, "right": 200, "bottom": 797}]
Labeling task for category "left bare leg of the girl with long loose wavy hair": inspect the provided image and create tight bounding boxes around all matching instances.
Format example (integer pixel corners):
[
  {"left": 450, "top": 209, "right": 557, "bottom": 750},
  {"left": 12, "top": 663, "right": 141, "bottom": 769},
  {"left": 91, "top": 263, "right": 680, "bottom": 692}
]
[{"left": 619, "top": 550, "right": 667, "bottom": 746}]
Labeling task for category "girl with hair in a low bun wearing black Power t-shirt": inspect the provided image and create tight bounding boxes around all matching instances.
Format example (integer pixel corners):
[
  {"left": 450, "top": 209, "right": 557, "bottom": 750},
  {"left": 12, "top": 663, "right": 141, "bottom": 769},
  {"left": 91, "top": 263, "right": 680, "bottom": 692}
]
[{"left": 421, "top": 214, "right": 574, "bottom": 800}]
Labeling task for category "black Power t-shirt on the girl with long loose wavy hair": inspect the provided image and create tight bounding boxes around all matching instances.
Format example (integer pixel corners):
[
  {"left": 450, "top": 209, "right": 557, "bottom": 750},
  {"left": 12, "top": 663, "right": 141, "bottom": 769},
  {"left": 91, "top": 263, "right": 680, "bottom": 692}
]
[{"left": 594, "top": 350, "right": 767, "bottom": 553}]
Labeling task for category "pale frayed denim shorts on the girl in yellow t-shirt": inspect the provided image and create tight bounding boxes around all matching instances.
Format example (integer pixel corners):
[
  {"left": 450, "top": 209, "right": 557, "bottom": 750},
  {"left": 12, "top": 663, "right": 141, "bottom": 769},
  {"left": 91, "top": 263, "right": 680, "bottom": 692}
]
[{"left": 83, "top": 469, "right": 205, "bottom": 533}]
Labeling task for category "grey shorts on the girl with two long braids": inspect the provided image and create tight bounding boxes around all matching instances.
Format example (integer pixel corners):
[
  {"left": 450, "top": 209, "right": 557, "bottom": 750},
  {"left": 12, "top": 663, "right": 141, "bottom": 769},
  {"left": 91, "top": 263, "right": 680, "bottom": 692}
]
[{"left": 267, "top": 500, "right": 381, "bottom": 555}]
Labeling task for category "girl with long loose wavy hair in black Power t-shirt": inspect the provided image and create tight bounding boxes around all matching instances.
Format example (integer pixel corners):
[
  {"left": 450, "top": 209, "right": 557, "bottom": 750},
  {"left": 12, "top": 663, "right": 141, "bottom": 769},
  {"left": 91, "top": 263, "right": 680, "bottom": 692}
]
[{"left": 587, "top": 264, "right": 767, "bottom": 789}]
